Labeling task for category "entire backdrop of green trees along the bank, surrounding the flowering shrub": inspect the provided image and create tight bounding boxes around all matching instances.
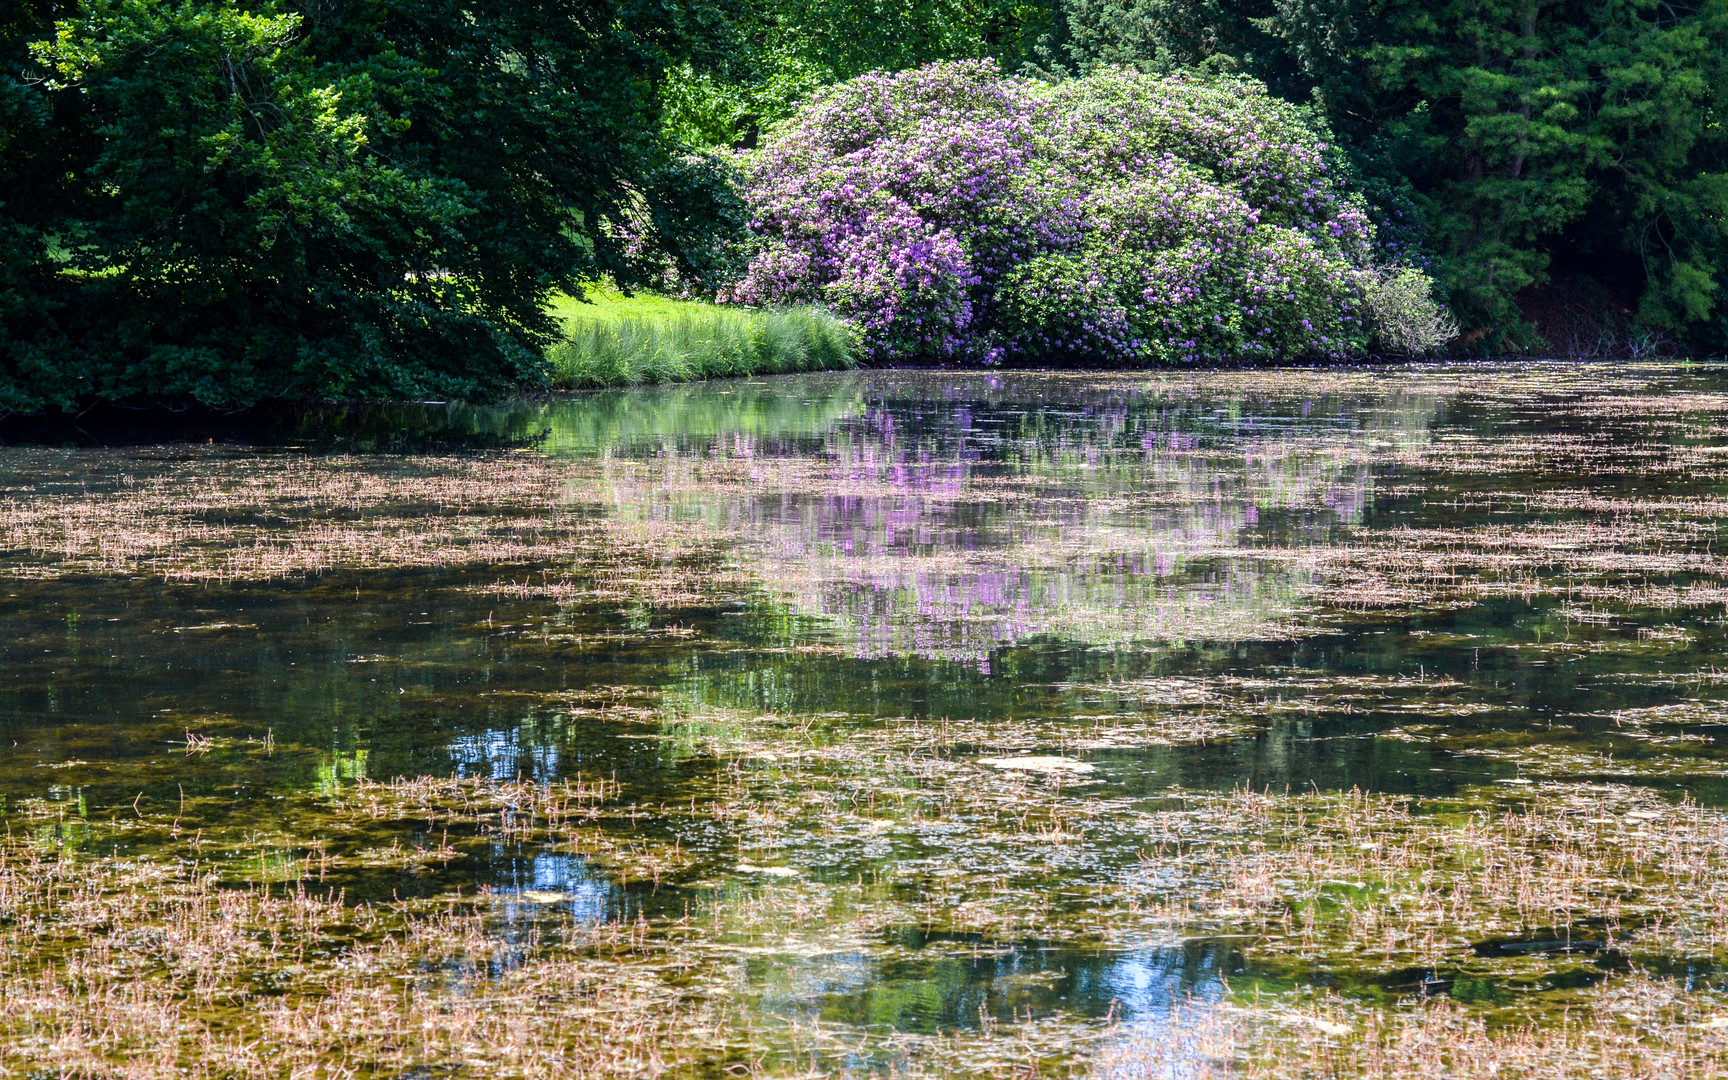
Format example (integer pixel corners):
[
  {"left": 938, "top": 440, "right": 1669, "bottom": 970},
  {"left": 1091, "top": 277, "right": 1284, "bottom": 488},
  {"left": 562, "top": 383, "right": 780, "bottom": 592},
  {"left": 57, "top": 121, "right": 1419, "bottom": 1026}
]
[{"left": 0, "top": 0, "right": 1728, "bottom": 383}]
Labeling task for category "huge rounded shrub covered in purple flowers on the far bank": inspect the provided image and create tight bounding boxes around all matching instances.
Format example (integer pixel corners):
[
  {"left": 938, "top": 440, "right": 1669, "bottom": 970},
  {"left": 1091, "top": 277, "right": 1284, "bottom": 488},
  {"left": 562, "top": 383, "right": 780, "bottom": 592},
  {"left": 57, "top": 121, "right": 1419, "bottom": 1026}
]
[{"left": 722, "top": 60, "right": 1426, "bottom": 363}]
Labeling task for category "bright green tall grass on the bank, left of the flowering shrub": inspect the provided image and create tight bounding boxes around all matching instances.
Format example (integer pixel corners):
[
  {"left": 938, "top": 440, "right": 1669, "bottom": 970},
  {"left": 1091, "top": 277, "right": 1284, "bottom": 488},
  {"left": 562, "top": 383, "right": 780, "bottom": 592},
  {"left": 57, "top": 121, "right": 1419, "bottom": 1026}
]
[{"left": 546, "top": 290, "right": 857, "bottom": 391}]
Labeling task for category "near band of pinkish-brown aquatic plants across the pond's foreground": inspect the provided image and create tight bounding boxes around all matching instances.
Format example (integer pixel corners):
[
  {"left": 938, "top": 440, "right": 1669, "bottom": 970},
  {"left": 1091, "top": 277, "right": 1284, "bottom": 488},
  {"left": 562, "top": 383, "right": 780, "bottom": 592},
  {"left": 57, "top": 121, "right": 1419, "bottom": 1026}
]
[{"left": 10, "top": 729, "right": 1728, "bottom": 1080}]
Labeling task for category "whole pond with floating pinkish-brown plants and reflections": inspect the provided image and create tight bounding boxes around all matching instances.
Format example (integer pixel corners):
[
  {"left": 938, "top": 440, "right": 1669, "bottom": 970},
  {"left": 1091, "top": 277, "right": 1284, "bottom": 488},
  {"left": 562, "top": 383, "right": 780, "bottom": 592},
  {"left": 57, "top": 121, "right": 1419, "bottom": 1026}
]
[{"left": 0, "top": 363, "right": 1728, "bottom": 1077}]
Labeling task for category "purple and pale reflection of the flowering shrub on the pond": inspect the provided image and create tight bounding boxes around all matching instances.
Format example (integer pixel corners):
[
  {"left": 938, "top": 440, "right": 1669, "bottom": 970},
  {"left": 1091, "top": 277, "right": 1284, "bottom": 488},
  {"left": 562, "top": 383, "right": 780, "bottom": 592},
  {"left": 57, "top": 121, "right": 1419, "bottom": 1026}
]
[{"left": 566, "top": 375, "right": 1445, "bottom": 665}]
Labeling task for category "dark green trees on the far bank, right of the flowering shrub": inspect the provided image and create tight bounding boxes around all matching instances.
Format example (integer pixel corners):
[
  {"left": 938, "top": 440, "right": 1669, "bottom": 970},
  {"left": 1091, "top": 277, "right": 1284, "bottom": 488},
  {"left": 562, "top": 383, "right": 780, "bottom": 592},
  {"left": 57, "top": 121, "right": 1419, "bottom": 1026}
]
[{"left": 1039, "top": 0, "right": 1728, "bottom": 347}]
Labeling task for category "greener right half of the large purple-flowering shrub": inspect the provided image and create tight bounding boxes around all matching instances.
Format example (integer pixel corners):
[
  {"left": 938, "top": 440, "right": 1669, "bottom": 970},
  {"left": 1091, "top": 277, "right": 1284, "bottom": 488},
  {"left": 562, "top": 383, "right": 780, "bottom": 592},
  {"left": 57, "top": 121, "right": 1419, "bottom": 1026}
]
[{"left": 1001, "top": 67, "right": 1382, "bottom": 363}]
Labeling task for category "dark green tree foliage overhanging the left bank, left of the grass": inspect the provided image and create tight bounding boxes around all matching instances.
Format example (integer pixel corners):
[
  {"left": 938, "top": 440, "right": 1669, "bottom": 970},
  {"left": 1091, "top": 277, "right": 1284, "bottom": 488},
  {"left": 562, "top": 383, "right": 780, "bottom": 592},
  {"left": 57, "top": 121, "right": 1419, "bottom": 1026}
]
[{"left": 0, "top": 0, "right": 741, "bottom": 411}]
